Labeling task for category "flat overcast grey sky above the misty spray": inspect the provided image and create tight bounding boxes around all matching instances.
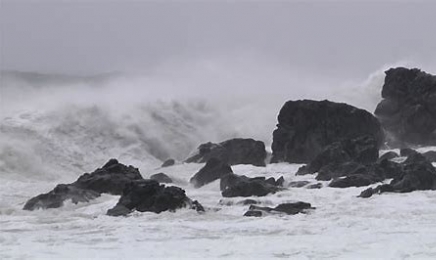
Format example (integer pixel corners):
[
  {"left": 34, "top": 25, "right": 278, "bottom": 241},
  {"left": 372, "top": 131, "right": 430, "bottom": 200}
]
[{"left": 0, "top": 0, "right": 436, "bottom": 77}]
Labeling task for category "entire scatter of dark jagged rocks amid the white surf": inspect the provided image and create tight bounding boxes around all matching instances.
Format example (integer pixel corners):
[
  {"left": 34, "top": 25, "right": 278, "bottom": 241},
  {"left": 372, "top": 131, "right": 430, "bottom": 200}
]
[{"left": 24, "top": 68, "right": 436, "bottom": 216}]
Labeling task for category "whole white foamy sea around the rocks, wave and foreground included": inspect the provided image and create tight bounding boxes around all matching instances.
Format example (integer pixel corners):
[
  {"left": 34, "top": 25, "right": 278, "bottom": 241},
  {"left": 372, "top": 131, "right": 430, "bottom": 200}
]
[{"left": 0, "top": 60, "right": 436, "bottom": 259}]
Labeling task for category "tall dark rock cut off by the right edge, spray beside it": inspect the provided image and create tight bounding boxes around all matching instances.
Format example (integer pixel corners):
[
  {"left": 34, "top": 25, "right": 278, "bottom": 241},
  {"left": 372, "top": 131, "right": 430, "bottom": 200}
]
[{"left": 375, "top": 67, "right": 436, "bottom": 146}]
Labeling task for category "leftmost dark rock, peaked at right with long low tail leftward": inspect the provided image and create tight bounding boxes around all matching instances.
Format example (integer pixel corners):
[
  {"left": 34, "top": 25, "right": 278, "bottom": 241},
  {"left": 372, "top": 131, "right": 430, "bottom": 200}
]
[{"left": 24, "top": 159, "right": 142, "bottom": 210}]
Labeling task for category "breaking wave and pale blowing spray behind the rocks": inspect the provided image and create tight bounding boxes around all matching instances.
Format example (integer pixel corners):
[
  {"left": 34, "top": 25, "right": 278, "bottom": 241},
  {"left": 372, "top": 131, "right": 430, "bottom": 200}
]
[{"left": 0, "top": 57, "right": 436, "bottom": 178}]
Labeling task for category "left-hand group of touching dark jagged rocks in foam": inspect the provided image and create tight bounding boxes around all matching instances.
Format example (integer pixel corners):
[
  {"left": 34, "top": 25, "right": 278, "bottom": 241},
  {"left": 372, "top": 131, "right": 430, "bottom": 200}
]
[{"left": 24, "top": 159, "right": 204, "bottom": 216}]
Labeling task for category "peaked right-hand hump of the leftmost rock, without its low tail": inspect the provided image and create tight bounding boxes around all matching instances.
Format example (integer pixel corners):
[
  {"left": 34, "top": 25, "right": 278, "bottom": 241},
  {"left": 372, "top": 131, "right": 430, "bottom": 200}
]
[{"left": 73, "top": 159, "right": 143, "bottom": 195}]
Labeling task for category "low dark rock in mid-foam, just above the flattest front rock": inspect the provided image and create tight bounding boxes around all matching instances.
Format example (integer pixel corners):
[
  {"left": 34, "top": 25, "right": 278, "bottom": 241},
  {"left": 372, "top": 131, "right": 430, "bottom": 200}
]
[{"left": 220, "top": 174, "right": 283, "bottom": 197}]
